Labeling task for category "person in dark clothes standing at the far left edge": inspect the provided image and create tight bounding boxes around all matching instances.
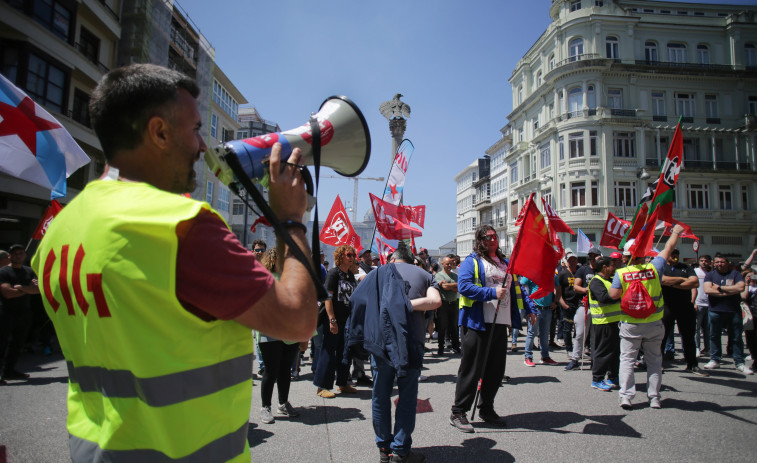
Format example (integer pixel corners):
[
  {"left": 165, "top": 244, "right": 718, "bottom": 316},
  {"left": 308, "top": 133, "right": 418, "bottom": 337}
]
[{"left": 0, "top": 244, "right": 39, "bottom": 381}]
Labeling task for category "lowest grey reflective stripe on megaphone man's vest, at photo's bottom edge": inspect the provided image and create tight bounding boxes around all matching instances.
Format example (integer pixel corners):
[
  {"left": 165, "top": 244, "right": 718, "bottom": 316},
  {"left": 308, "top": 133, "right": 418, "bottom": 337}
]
[{"left": 68, "top": 423, "right": 250, "bottom": 463}]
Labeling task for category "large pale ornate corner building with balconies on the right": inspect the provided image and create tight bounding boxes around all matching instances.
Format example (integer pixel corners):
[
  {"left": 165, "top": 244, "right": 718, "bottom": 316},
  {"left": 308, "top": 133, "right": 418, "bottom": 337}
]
[{"left": 458, "top": 0, "right": 757, "bottom": 257}]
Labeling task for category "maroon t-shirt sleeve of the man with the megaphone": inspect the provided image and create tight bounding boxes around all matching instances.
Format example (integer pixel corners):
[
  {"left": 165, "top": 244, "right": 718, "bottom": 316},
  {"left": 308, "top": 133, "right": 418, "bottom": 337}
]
[{"left": 176, "top": 210, "right": 273, "bottom": 321}]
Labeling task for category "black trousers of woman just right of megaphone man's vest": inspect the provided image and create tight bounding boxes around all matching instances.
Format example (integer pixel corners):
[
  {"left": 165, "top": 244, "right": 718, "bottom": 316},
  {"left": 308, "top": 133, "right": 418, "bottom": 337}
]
[{"left": 260, "top": 341, "right": 300, "bottom": 407}]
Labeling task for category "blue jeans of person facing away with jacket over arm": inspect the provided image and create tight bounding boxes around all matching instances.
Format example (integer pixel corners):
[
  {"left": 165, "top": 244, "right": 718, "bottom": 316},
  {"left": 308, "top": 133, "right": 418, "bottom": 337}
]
[{"left": 371, "top": 356, "right": 421, "bottom": 456}]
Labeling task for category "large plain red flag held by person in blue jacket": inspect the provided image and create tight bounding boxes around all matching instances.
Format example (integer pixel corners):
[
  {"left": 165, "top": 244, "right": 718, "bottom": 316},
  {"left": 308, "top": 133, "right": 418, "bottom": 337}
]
[{"left": 507, "top": 198, "right": 562, "bottom": 299}]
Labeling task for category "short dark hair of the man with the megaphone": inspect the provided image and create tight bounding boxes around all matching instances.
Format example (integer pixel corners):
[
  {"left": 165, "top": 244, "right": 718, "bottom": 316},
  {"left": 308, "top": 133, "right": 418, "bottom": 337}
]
[{"left": 89, "top": 64, "right": 200, "bottom": 161}]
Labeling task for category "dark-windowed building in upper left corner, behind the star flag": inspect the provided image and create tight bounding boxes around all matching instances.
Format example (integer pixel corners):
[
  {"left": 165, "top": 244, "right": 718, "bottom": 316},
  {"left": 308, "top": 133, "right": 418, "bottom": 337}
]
[{"left": 0, "top": 0, "right": 122, "bottom": 249}]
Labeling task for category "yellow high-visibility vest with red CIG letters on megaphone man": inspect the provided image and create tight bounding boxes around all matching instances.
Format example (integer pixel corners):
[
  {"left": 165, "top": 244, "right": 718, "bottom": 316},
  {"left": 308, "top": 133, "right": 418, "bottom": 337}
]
[{"left": 32, "top": 181, "right": 253, "bottom": 462}]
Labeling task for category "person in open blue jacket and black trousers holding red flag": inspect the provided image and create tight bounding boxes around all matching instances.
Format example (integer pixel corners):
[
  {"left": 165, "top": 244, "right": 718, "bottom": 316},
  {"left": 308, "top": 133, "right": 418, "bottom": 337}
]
[{"left": 449, "top": 225, "right": 536, "bottom": 432}]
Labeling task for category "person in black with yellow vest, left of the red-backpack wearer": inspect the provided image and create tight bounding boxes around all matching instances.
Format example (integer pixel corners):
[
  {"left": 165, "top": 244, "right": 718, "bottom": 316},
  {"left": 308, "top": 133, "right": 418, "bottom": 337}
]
[{"left": 589, "top": 257, "right": 622, "bottom": 392}]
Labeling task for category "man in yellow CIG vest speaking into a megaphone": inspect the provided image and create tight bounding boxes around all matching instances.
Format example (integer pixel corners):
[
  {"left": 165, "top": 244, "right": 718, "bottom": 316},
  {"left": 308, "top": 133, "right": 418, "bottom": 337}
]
[{"left": 32, "top": 64, "right": 317, "bottom": 463}]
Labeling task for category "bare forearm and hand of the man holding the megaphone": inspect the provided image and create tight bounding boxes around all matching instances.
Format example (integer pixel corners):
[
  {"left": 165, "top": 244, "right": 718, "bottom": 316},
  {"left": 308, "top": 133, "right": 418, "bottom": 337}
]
[{"left": 234, "top": 143, "right": 318, "bottom": 341}]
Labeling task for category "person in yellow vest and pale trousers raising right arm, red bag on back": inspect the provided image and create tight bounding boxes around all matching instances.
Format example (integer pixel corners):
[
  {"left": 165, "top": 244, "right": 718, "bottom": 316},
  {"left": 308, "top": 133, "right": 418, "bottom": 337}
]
[{"left": 609, "top": 224, "right": 683, "bottom": 410}]
